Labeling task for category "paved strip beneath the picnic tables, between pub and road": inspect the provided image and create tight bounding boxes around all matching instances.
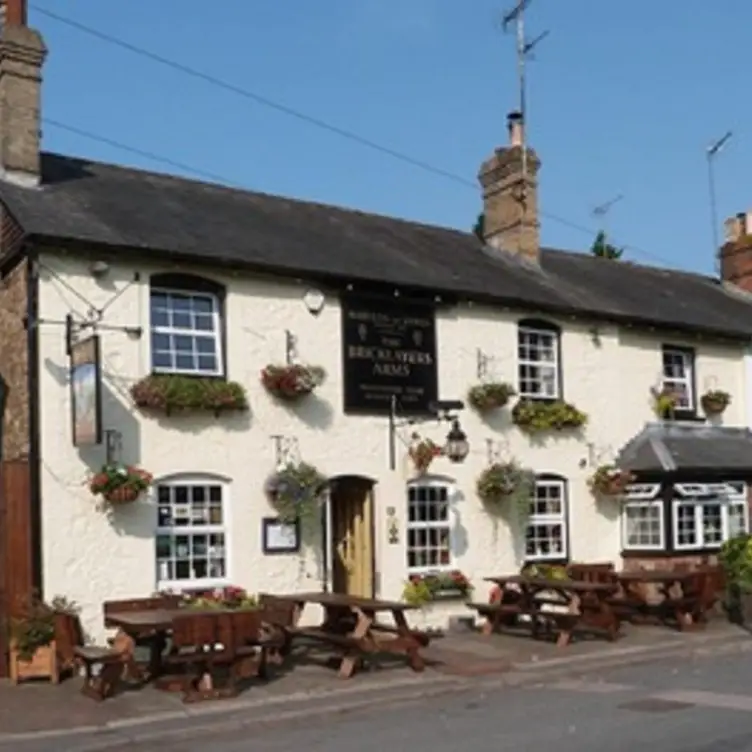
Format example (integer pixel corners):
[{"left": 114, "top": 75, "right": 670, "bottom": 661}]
[{"left": 0, "top": 619, "right": 752, "bottom": 752}]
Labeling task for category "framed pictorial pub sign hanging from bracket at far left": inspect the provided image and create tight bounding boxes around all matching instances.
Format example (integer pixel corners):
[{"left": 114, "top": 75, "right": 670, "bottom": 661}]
[{"left": 70, "top": 334, "right": 102, "bottom": 447}]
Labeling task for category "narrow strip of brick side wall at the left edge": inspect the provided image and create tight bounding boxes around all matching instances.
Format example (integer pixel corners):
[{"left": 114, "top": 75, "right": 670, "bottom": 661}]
[{"left": 0, "top": 259, "right": 29, "bottom": 461}]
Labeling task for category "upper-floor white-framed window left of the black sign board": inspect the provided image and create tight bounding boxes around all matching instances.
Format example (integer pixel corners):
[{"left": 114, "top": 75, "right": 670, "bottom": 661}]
[{"left": 150, "top": 287, "right": 224, "bottom": 376}]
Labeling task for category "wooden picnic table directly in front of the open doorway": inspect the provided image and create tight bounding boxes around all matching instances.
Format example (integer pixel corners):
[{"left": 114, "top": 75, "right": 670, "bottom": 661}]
[{"left": 276, "top": 593, "right": 428, "bottom": 679}]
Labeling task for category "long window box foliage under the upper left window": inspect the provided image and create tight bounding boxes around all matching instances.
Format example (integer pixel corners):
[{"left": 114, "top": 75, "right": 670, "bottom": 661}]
[{"left": 131, "top": 374, "right": 248, "bottom": 415}]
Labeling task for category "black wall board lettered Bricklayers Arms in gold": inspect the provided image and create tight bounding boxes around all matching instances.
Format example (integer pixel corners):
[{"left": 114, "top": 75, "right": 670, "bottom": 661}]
[{"left": 341, "top": 295, "right": 438, "bottom": 415}]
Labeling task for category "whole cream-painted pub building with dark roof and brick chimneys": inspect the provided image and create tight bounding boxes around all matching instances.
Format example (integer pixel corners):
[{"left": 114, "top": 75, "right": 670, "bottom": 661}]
[{"left": 0, "top": 0, "right": 752, "bottom": 652}]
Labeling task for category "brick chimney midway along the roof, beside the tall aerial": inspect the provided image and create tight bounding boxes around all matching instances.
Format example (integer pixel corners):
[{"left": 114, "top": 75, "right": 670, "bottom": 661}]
[{"left": 478, "top": 112, "right": 540, "bottom": 264}]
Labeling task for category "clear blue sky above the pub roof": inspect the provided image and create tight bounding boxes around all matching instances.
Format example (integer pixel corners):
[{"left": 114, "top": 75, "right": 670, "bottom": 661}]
[{"left": 30, "top": 0, "right": 752, "bottom": 273}]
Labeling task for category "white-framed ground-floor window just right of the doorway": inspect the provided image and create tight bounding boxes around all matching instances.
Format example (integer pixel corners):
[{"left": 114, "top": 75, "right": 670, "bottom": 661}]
[{"left": 407, "top": 478, "right": 454, "bottom": 574}]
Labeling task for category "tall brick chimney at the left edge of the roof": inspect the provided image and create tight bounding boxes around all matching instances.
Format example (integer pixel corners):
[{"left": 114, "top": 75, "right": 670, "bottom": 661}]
[{"left": 0, "top": 0, "right": 47, "bottom": 186}]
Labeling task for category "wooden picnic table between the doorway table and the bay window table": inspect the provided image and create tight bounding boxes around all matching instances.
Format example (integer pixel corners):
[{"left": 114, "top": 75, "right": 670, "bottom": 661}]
[{"left": 467, "top": 574, "right": 620, "bottom": 647}]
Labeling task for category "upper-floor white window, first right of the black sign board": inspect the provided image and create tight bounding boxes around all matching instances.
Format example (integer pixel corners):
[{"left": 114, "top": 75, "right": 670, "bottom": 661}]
[{"left": 517, "top": 321, "right": 561, "bottom": 399}]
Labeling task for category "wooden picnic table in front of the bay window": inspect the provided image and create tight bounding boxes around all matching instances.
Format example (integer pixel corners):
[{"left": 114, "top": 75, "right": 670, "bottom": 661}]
[{"left": 615, "top": 567, "right": 717, "bottom": 630}]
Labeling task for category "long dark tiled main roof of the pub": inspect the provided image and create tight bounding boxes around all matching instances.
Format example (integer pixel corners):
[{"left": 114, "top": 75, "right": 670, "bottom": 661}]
[{"left": 0, "top": 154, "right": 752, "bottom": 339}]
